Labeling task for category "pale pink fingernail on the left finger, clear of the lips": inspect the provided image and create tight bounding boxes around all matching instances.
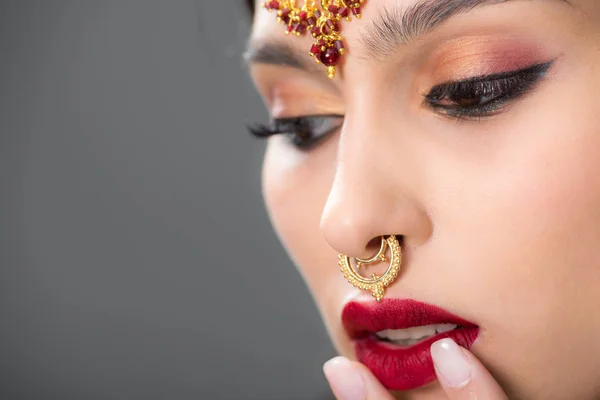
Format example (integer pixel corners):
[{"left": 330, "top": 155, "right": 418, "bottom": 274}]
[{"left": 323, "top": 357, "right": 366, "bottom": 400}]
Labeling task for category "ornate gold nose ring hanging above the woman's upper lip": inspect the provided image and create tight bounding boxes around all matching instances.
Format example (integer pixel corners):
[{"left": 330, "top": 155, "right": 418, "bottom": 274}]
[{"left": 339, "top": 235, "right": 402, "bottom": 302}]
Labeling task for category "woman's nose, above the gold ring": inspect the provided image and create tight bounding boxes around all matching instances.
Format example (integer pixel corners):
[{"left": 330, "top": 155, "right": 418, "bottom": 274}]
[{"left": 321, "top": 112, "right": 432, "bottom": 258}]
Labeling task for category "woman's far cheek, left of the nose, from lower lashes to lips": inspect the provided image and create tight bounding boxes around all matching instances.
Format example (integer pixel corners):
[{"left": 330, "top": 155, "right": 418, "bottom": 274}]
[{"left": 263, "top": 136, "right": 354, "bottom": 357}]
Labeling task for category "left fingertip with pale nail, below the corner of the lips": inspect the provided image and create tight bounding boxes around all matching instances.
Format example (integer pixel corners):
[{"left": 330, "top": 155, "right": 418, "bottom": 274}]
[{"left": 323, "top": 357, "right": 394, "bottom": 400}]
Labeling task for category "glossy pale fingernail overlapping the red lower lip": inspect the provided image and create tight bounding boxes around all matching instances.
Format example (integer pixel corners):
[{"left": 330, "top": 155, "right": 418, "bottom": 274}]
[{"left": 431, "top": 339, "right": 471, "bottom": 388}]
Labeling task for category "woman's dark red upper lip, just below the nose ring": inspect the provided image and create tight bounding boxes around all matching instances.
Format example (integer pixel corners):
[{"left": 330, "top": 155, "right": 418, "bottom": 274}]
[{"left": 342, "top": 299, "right": 477, "bottom": 339}]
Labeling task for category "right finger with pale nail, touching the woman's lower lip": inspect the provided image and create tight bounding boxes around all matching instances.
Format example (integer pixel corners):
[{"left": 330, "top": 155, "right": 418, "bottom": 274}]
[{"left": 431, "top": 339, "right": 508, "bottom": 400}]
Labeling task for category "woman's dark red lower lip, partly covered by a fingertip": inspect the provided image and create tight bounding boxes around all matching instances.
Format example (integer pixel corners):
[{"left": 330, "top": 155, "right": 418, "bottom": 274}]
[{"left": 354, "top": 327, "right": 479, "bottom": 390}]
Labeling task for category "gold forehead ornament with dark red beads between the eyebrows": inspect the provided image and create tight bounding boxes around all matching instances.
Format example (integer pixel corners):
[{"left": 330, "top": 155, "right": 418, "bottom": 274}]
[{"left": 263, "top": 0, "right": 365, "bottom": 79}]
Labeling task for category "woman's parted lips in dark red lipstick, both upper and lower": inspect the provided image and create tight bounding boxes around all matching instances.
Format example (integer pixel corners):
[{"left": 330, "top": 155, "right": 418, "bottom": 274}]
[{"left": 342, "top": 299, "right": 479, "bottom": 390}]
